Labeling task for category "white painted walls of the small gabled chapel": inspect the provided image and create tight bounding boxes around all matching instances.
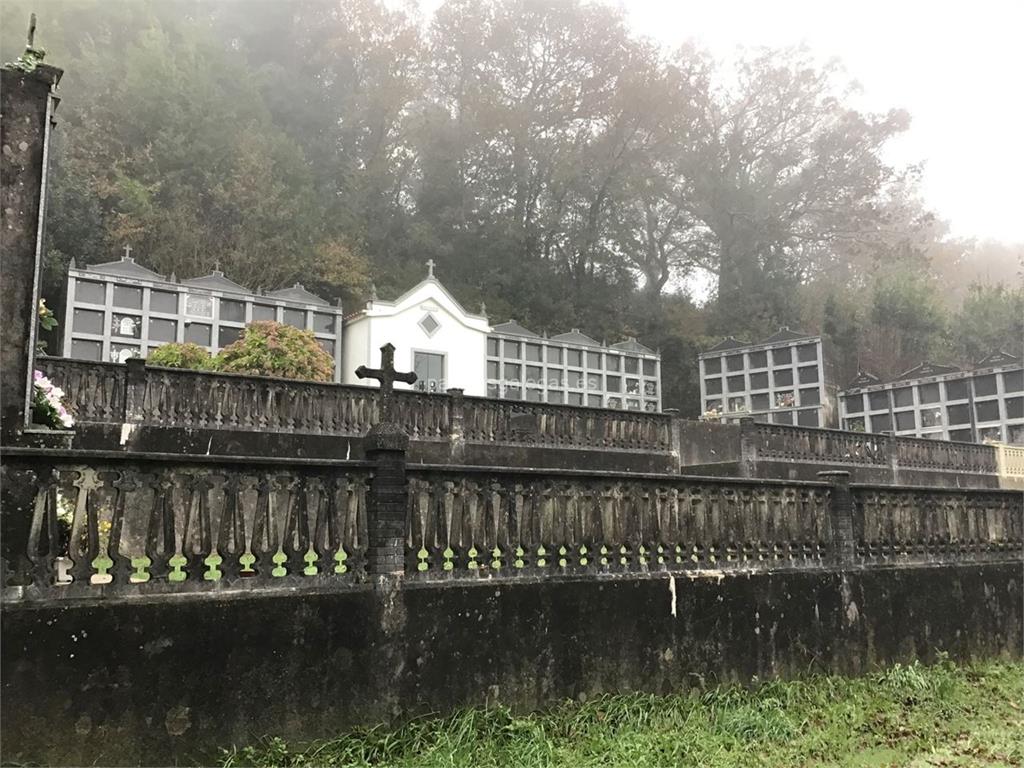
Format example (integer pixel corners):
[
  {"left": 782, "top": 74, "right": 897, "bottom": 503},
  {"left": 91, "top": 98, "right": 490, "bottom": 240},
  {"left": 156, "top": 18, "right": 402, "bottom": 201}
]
[{"left": 342, "top": 279, "right": 490, "bottom": 396}]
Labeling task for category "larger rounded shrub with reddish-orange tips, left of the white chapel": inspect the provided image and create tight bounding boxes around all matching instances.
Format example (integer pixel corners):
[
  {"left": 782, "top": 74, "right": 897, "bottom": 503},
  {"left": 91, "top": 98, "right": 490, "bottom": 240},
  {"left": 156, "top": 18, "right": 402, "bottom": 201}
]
[{"left": 217, "top": 322, "right": 334, "bottom": 381}]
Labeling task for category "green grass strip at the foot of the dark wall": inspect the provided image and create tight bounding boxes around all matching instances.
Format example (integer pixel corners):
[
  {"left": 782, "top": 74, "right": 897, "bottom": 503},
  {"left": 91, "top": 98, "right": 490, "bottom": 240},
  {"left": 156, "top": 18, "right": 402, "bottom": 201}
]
[{"left": 223, "top": 660, "right": 1024, "bottom": 768}]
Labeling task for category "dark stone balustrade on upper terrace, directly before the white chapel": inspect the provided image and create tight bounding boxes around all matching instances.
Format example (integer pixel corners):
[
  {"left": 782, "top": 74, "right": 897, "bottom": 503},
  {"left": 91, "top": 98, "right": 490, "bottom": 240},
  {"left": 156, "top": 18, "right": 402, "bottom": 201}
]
[{"left": 37, "top": 357, "right": 672, "bottom": 455}]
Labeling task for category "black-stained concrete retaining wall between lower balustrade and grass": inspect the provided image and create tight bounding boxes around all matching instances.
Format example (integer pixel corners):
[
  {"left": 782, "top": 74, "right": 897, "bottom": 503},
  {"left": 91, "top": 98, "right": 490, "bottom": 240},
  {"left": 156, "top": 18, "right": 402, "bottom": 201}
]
[{"left": 2, "top": 561, "right": 1024, "bottom": 765}]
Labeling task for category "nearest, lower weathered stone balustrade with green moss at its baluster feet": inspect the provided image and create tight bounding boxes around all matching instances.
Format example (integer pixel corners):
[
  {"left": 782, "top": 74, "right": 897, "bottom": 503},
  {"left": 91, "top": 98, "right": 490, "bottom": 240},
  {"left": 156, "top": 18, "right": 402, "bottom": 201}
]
[{"left": 3, "top": 449, "right": 1024, "bottom": 599}]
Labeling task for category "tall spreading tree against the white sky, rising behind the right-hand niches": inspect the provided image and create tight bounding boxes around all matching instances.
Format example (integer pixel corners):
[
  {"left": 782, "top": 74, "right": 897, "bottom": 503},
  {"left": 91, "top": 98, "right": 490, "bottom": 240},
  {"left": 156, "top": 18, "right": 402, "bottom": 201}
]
[{"left": 687, "top": 51, "right": 907, "bottom": 333}]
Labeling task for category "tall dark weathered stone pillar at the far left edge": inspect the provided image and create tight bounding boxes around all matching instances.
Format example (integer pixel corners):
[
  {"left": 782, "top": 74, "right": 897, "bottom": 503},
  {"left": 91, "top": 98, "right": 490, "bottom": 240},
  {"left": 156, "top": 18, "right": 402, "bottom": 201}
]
[{"left": 0, "top": 52, "right": 68, "bottom": 441}]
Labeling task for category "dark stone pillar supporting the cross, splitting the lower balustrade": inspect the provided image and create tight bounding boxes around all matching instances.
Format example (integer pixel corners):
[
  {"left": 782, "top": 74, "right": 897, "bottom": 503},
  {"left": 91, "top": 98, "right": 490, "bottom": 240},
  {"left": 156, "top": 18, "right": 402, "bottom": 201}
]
[{"left": 366, "top": 422, "right": 409, "bottom": 577}]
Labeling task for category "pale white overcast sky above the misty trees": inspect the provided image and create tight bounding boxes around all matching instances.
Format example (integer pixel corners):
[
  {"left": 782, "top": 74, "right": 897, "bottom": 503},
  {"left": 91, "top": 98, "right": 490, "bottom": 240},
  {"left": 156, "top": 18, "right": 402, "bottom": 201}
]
[{"left": 420, "top": 0, "right": 1024, "bottom": 243}]
